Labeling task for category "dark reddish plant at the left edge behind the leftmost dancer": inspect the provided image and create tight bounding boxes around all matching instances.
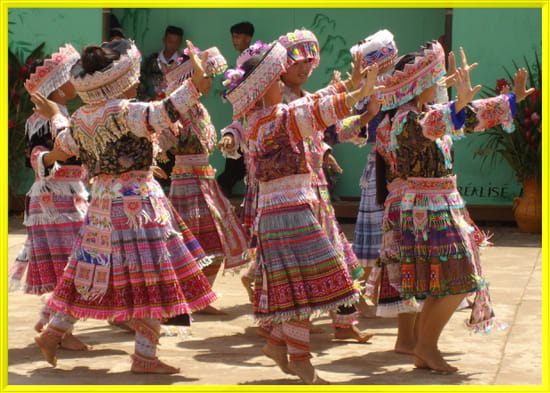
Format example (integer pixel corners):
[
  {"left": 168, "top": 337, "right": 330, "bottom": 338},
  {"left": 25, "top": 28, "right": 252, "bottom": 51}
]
[{"left": 8, "top": 43, "right": 44, "bottom": 211}]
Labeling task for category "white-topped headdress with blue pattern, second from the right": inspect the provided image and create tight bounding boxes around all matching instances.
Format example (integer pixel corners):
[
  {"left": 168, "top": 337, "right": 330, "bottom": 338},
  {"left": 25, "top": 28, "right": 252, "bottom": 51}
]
[{"left": 349, "top": 29, "right": 397, "bottom": 68}]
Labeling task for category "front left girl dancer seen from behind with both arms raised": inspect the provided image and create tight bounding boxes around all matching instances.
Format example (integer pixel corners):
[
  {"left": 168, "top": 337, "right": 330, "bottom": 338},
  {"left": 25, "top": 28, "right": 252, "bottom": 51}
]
[{"left": 32, "top": 39, "right": 216, "bottom": 374}]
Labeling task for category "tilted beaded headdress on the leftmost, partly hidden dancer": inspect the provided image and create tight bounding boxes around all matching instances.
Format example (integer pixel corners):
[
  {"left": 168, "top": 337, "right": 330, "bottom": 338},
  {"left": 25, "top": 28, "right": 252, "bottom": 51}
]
[{"left": 25, "top": 44, "right": 80, "bottom": 97}]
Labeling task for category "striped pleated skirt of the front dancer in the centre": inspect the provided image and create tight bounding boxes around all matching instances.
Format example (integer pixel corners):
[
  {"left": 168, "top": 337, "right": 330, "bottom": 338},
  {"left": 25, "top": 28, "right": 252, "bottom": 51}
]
[{"left": 254, "top": 204, "right": 358, "bottom": 321}]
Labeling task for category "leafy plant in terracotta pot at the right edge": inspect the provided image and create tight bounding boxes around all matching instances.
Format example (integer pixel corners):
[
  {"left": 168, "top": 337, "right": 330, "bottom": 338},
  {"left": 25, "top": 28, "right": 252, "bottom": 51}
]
[{"left": 474, "top": 52, "right": 542, "bottom": 233}]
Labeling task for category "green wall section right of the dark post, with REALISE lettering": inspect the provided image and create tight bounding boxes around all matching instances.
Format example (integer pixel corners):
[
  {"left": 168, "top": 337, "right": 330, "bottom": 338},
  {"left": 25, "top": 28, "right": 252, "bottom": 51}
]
[{"left": 453, "top": 8, "right": 546, "bottom": 205}]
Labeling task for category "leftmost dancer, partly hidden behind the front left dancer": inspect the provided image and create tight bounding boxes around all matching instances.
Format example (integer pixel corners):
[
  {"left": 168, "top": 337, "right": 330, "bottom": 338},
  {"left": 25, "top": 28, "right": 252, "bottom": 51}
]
[{"left": 20, "top": 44, "right": 90, "bottom": 350}]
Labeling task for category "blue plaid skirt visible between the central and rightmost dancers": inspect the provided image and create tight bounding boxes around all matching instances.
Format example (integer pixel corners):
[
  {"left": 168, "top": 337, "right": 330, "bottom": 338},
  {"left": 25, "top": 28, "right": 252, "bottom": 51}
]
[{"left": 353, "top": 149, "right": 384, "bottom": 267}]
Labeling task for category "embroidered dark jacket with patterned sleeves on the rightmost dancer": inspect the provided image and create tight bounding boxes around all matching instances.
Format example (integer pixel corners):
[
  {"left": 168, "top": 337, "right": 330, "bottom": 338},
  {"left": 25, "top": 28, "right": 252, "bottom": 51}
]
[{"left": 376, "top": 95, "right": 515, "bottom": 182}]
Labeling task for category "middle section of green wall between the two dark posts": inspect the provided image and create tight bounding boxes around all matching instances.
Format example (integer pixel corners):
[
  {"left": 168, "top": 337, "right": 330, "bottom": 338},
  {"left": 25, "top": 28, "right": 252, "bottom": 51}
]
[{"left": 112, "top": 8, "right": 444, "bottom": 197}]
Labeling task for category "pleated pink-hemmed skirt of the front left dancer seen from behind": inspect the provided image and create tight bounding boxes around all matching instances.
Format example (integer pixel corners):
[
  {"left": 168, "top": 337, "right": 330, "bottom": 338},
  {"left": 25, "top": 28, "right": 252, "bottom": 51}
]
[{"left": 48, "top": 171, "right": 216, "bottom": 320}]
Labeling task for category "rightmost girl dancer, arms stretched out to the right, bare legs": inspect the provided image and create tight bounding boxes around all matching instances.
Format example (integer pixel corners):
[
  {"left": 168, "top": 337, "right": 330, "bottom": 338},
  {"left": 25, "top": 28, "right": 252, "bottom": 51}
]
[{"left": 376, "top": 41, "right": 531, "bottom": 372}]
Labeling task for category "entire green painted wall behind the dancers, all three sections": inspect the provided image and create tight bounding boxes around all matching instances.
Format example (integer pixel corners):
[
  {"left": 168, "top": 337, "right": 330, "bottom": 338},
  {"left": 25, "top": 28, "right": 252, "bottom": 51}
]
[{"left": 8, "top": 8, "right": 542, "bottom": 204}]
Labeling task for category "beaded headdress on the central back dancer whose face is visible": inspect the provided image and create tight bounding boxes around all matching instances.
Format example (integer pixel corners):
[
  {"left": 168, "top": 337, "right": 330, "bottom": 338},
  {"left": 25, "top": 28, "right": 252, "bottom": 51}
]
[{"left": 279, "top": 29, "right": 321, "bottom": 68}]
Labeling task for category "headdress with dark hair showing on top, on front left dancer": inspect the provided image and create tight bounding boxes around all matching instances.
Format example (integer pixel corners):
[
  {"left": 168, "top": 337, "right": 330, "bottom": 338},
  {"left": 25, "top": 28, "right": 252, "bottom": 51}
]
[{"left": 71, "top": 39, "right": 141, "bottom": 104}]
